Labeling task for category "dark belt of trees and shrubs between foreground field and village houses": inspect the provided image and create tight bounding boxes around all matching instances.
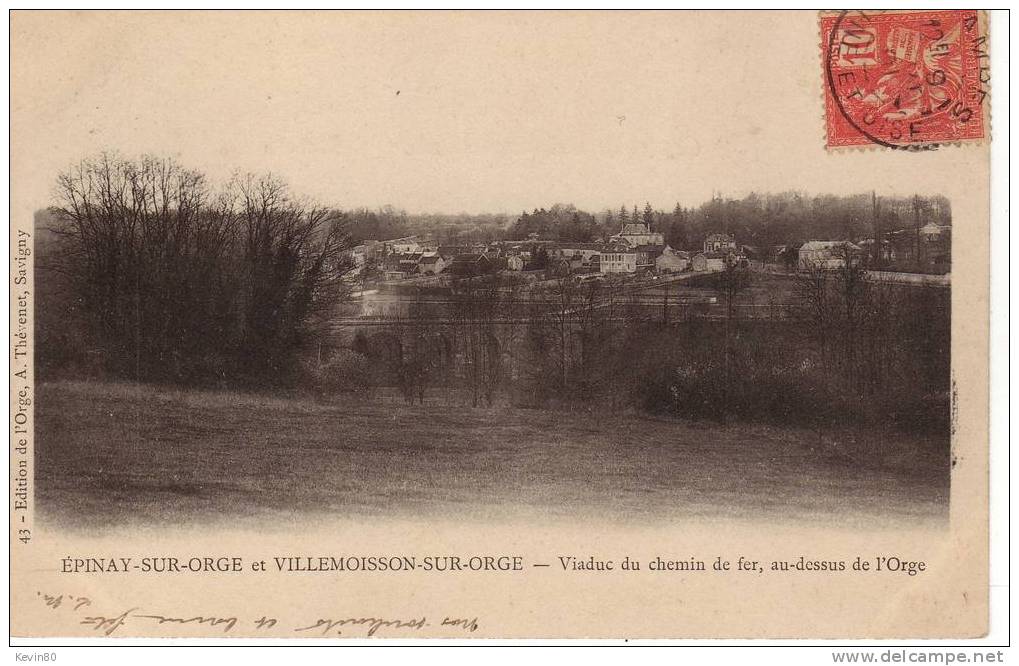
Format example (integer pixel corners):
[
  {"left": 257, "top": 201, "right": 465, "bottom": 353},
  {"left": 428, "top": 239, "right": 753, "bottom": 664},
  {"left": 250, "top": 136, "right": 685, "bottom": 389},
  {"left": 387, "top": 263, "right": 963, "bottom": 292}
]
[{"left": 319, "top": 263, "right": 951, "bottom": 436}]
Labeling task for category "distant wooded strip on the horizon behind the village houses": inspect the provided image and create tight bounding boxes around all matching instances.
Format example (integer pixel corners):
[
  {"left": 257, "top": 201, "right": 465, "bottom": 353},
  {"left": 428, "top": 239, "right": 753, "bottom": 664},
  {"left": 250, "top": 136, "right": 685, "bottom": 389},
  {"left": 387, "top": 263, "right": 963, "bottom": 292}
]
[{"left": 291, "top": 191, "right": 952, "bottom": 249}]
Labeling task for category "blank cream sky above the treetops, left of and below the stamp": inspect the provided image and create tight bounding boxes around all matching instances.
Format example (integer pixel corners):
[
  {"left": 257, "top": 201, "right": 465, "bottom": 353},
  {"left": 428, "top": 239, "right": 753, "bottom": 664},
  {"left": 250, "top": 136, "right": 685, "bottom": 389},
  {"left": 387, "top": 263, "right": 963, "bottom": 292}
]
[{"left": 11, "top": 11, "right": 986, "bottom": 214}]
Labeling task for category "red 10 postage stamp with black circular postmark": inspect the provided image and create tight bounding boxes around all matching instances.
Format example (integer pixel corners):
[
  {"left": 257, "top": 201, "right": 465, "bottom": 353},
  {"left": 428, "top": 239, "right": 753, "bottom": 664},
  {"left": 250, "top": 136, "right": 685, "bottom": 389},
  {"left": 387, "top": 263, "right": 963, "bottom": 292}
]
[{"left": 820, "top": 9, "right": 990, "bottom": 150}]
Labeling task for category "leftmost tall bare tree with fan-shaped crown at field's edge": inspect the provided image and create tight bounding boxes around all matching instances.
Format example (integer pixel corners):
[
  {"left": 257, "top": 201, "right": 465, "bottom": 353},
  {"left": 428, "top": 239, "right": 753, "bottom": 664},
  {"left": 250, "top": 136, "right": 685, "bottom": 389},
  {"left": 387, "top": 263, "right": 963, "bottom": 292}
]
[{"left": 54, "top": 154, "right": 233, "bottom": 379}]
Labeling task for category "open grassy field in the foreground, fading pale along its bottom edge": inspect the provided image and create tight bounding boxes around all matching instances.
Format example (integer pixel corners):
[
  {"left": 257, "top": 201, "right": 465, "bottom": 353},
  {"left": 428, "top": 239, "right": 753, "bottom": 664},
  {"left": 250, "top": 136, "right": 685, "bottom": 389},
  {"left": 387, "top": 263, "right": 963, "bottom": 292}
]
[{"left": 36, "top": 382, "right": 949, "bottom": 531}]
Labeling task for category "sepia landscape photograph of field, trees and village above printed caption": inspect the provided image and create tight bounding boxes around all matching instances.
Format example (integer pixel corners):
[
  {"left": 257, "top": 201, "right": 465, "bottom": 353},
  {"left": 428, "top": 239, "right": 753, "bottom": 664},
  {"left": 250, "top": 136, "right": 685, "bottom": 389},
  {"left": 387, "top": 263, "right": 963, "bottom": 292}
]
[{"left": 35, "top": 175, "right": 952, "bottom": 530}]
